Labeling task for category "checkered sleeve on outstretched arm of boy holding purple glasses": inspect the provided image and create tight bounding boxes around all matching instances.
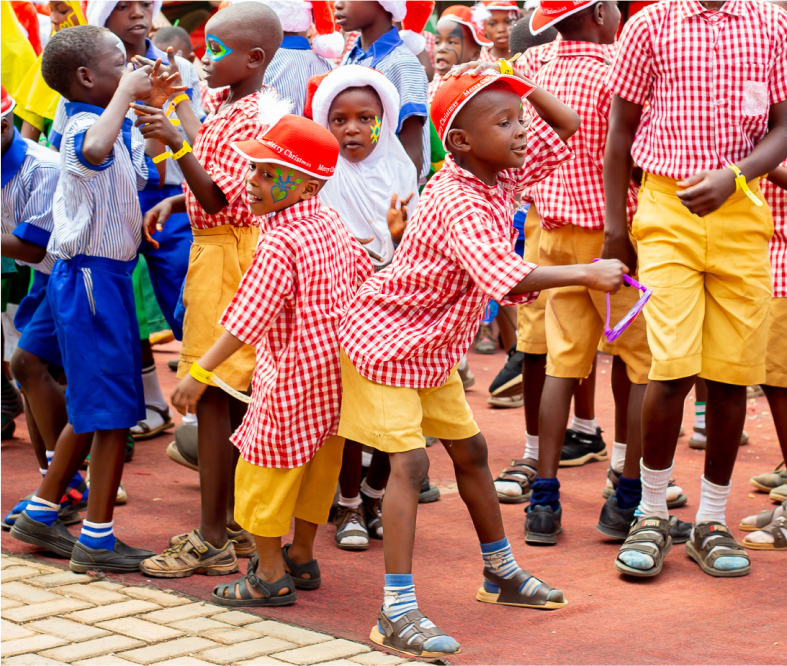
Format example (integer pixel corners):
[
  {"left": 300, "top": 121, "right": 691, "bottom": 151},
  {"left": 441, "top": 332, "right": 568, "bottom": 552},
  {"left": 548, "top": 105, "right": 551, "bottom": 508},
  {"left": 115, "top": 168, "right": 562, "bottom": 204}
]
[{"left": 448, "top": 212, "right": 538, "bottom": 304}]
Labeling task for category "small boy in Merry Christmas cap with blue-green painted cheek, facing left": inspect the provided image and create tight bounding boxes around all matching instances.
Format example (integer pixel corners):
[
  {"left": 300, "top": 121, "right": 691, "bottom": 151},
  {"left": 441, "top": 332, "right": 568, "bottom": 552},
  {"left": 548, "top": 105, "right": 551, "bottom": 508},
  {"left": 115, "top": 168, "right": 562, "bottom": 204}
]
[{"left": 167, "top": 113, "right": 372, "bottom": 606}]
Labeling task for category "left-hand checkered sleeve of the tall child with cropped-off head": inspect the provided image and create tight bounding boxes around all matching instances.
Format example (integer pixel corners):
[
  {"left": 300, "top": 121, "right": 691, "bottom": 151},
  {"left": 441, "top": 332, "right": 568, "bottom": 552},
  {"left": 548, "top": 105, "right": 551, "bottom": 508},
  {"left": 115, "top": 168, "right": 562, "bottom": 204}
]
[{"left": 607, "top": 12, "right": 653, "bottom": 104}]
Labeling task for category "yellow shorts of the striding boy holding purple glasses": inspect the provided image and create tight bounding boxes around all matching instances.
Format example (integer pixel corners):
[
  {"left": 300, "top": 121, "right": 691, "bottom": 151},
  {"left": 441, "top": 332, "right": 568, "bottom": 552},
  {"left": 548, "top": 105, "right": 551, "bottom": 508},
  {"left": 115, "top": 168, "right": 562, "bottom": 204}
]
[{"left": 339, "top": 350, "right": 480, "bottom": 453}]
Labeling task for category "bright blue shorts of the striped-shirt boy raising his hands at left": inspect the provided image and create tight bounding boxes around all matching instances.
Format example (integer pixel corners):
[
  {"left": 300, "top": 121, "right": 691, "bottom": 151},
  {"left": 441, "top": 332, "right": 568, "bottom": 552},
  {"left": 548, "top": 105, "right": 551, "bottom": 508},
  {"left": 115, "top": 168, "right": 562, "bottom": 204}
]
[{"left": 47, "top": 255, "right": 145, "bottom": 433}]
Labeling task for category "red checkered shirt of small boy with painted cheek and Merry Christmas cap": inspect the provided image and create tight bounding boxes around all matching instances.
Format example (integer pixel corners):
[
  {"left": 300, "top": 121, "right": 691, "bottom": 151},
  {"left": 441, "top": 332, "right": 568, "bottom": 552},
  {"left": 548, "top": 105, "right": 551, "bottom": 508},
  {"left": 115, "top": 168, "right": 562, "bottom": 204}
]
[{"left": 221, "top": 197, "right": 372, "bottom": 468}]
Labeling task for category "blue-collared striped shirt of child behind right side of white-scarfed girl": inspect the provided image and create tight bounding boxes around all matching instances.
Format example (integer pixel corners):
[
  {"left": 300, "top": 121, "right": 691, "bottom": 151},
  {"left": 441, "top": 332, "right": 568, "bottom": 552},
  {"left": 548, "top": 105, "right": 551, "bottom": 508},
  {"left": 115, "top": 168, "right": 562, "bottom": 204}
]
[{"left": 342, "top": 28, "right": 431, "bottom": 179}]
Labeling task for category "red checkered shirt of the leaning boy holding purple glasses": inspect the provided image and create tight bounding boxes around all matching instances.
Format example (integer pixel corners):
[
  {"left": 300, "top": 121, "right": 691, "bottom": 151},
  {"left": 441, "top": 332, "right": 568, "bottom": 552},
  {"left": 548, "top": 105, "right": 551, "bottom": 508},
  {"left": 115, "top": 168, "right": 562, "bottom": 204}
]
[{"left": 339, "top": 118, "right": 571, "bottom": 388}]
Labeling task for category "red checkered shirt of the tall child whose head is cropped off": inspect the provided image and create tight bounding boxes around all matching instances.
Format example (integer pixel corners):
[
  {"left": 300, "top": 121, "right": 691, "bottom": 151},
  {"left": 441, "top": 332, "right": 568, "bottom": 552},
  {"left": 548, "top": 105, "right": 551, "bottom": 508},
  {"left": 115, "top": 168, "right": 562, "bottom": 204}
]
[{"left": 609, "top": 0, "right": 787, "bottom": 179}]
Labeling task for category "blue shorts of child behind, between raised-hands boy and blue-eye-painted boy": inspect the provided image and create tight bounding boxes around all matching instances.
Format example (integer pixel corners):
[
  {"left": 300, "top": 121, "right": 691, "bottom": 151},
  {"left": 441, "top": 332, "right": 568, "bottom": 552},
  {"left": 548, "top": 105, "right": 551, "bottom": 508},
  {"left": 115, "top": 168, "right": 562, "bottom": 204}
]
[{"left": 139, "top": 186, "right": 193, "bottom": 340}]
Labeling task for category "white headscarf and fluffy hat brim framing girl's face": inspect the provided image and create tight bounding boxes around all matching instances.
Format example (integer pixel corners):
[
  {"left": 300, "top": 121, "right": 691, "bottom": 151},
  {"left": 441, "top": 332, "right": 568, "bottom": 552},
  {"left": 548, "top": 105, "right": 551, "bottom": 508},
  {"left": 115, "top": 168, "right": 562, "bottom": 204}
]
[{"left": 312, "top": 65, "right": 418, "bottom": 266}]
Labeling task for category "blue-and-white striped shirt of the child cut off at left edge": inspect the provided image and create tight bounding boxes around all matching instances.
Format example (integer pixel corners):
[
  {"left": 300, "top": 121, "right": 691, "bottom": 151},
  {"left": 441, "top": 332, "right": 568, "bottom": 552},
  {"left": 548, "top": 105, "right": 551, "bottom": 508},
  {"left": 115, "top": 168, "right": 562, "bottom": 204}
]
[{"left": 2, "top": 130, "right": 60, "bottom": 275}]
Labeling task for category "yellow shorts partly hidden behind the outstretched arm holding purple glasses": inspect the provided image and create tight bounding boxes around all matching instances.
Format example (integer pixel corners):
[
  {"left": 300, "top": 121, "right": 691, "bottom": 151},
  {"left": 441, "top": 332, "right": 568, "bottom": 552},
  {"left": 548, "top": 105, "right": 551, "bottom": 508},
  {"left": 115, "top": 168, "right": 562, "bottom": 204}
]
[{"left": 538, "top": 224, "right": 651, "bottom": 384}]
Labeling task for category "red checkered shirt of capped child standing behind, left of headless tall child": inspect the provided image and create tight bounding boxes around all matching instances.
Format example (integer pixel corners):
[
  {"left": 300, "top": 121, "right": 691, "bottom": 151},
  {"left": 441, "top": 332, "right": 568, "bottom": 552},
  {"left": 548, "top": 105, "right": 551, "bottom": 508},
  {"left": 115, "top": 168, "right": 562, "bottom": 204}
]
[{"left": 530, "top": 41, "right": 637, "bottom": 230}]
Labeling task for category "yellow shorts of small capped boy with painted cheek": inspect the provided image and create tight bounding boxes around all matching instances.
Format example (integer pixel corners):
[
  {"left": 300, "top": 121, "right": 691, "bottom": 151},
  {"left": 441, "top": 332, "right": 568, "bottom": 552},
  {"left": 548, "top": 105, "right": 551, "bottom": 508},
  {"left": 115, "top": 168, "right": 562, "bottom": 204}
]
[{"left": 235, "top": 436, "right": 344, "bottom": 537}]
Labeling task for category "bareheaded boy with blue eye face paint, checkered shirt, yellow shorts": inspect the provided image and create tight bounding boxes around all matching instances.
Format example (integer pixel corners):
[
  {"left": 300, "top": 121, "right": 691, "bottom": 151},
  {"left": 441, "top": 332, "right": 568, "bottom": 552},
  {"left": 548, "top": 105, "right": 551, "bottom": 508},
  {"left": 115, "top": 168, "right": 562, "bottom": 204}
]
[{"left": 135, "top": 2, "right": 282, "bottom": 578}]
